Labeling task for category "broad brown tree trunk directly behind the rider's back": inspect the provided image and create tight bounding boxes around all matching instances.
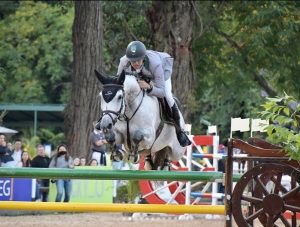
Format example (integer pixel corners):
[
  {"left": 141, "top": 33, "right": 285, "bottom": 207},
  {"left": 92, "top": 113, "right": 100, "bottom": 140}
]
[{"left": 147, "top": 1, "right": 196, "bottom": 118}]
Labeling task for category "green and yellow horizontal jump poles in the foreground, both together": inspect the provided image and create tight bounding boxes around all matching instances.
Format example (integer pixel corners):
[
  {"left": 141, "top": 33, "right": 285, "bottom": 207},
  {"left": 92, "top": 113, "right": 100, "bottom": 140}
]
[{"left": 0, "top": 168, "right": 240, "bottom": 215}]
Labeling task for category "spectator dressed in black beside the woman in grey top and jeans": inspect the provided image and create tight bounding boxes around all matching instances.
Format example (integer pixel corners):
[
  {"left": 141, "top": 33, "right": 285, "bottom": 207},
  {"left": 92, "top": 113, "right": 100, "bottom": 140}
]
[{"left": 31, "top": 144, "right": 50, "bottom": 202}]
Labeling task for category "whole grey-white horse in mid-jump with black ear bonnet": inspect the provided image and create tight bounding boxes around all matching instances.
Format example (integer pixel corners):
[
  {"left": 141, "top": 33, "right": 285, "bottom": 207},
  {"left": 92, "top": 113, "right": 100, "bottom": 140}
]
[{"left": 95, "top": 70, "right": 185, "bottom": 170}]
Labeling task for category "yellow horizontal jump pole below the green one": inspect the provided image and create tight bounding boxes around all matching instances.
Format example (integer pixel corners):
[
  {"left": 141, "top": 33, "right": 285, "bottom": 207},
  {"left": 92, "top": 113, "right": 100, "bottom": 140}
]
[{"left": 0, "top": 201, "right": 225, "bottom": 215}]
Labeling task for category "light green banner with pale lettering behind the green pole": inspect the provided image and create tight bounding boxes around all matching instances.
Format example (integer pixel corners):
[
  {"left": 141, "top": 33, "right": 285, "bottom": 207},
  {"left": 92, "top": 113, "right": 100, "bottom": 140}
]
[{"left": 49, "top": 166, "right": 113, "bottom": 203}]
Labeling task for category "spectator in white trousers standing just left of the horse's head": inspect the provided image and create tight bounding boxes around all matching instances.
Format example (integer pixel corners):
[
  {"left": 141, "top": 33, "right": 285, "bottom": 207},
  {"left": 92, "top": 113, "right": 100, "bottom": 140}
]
[{"left": 90, "top": 122, "right": 107, "bottom": 166}]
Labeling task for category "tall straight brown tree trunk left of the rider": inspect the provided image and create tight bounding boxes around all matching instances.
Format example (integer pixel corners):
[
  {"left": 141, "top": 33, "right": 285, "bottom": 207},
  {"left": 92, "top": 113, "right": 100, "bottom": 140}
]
[{"left": 65, "top": 1, "right": 103, "bottom": 157}]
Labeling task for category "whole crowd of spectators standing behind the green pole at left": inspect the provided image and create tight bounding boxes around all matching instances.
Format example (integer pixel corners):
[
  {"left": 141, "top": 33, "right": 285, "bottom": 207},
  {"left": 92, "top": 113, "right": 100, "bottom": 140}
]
[{"left": 0, "top": 134, "right": 110, "bottom": 202}]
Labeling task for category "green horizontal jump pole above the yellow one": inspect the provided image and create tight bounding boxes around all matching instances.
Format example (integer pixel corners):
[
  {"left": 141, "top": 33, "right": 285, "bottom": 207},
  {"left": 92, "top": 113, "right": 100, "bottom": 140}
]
[{"left": 0, "top": 167, "right": 240, "bottom": 182}]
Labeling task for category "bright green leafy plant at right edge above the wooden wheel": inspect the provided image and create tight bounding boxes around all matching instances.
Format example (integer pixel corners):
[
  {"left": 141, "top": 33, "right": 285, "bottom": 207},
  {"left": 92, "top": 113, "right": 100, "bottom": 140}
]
[{"left": 260, "top": 94, "right": 300, "bottom": 161}]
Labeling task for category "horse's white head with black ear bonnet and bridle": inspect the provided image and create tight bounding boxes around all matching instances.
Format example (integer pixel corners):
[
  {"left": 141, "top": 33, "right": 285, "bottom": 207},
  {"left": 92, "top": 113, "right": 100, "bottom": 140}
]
[{"left": 95, "top": 70, "right": 125, "bottom": 133}]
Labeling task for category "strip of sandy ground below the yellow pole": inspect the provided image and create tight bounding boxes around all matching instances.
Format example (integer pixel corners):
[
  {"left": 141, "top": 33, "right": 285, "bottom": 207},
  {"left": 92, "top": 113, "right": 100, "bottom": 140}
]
[{"left": 0, "top": 213, "right": 232, "bottom": 227}]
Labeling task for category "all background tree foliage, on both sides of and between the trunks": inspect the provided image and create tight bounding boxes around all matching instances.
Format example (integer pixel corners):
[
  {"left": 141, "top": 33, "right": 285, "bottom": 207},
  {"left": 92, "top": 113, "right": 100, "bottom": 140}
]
[{"left": 0, "top": 1, "right": 300, "bottom": 144}]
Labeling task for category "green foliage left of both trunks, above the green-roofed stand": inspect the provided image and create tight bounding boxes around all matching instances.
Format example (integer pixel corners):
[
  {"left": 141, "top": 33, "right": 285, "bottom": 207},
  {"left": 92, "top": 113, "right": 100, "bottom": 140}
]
[{"left": 0, "top": 1, "right": 74, "bottom": 103}]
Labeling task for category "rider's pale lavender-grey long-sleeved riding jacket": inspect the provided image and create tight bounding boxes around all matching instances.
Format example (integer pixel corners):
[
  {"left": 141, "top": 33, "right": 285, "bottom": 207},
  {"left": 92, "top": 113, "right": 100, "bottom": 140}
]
[{"left": 117, "top": 50, "right": 173, "bottom": 98}]
